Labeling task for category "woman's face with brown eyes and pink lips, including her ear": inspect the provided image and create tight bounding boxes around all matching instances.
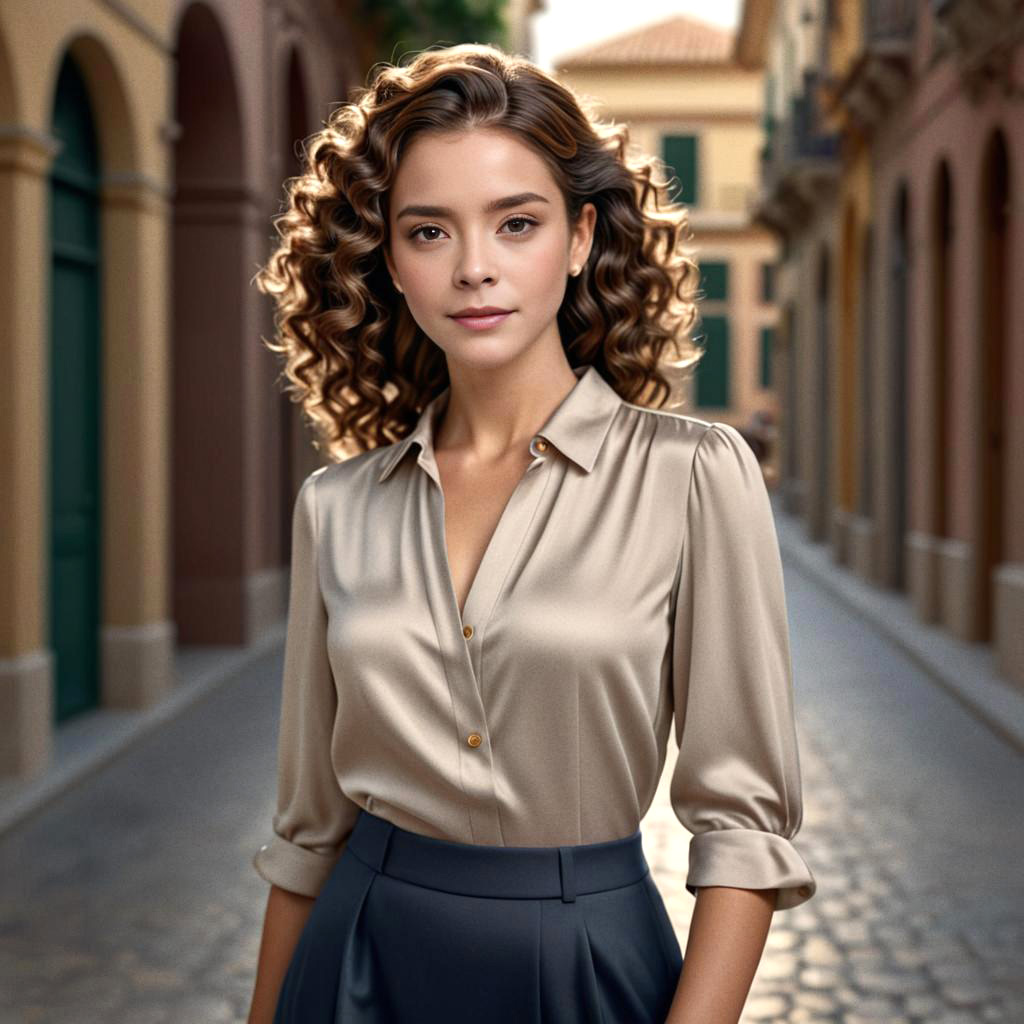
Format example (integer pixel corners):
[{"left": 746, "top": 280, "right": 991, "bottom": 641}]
[{"left": 387, "top": 129, "right": 596, "bottom": 368}]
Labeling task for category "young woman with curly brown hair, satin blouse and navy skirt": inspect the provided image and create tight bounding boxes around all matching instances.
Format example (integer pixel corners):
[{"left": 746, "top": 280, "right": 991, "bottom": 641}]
[{"left": 250, "top": 45, "right": 815, "bottom": 1024}]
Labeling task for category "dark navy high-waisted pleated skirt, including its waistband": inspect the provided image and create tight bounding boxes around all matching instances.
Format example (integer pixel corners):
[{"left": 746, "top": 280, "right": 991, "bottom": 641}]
[{"left": 274, "top": 810, "right": 683, "bottom": 1024}]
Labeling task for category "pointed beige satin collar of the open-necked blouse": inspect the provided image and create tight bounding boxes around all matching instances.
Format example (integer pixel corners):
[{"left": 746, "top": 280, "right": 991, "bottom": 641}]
[{"left": 378, "top": 364, "right": 622, "bottom": 481}]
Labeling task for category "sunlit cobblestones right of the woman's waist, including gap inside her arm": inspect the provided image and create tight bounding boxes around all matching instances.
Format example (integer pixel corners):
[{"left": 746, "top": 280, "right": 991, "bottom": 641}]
[{"left": 644, "top": 565, "right": 1024, "bottom": 1024}]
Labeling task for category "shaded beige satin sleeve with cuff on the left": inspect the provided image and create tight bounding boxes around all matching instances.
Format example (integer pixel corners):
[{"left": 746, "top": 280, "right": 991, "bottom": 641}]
[{"left": 252, "top": 468, "right": 359, "bottom": 897}]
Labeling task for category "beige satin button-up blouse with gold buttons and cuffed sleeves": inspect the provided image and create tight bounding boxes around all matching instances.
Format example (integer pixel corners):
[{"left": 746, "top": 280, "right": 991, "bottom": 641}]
[{"left": 253, "top": 367, "right": 816, "bottom": 909}]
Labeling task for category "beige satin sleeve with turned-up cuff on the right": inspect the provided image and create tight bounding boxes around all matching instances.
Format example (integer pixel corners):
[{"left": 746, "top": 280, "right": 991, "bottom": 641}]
[{"left": 670, "top": 423, "right": 817, "bottom": 910}]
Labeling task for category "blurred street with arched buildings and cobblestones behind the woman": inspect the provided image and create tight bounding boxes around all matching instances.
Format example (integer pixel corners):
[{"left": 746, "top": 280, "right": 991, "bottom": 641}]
[{"left": 0, "top": 0, "right": 1024, "bottom": 1024}]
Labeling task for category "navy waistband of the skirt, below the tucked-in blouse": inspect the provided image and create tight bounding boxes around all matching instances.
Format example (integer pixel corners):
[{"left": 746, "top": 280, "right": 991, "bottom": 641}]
[{"left": 346, "top": 808, "right": 650, "bottom": 903}]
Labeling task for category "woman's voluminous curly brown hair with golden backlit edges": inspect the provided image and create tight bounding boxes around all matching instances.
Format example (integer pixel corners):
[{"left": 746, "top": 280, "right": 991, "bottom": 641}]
[{"left": 255, "top": 43, "right": 702, "bottom": 460}]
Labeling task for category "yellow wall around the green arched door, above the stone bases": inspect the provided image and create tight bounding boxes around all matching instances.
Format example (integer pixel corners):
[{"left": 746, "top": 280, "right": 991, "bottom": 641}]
[{"left": 0, "top": 0, "right": 173, "bottom": 657}]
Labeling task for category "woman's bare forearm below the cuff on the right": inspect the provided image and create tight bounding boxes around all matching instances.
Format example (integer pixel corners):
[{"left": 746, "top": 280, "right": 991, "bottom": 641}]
[{"left": 666, "top": 886, "right": 778, "bottom": 1024}]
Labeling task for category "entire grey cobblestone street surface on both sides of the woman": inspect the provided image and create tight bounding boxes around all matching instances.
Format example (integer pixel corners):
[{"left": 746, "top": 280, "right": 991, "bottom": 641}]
[{"left": 0, "top": 548, "right": 1024, "bottom": 1024}]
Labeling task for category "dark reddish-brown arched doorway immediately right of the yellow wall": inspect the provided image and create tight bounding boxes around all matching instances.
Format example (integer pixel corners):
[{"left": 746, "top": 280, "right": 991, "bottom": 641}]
[{"left": 171, "top": 3, "right": 246, "bottom": 644}]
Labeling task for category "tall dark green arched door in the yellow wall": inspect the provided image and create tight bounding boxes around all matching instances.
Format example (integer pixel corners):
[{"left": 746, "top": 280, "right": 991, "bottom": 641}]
[{"left": 49, "top": 58, "right": 100, "bottom": 722}]
